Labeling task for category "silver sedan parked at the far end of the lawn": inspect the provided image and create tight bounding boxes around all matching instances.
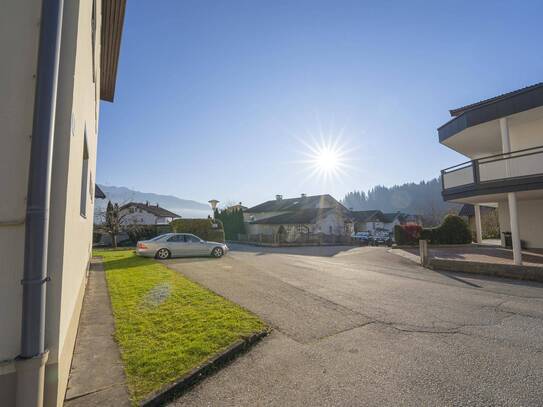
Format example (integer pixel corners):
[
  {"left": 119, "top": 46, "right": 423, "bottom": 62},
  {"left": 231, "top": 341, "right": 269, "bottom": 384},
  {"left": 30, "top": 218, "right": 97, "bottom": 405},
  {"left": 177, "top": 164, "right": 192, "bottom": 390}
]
[{"left": 136, "top": 233, "right": 228, "bottom": 260}]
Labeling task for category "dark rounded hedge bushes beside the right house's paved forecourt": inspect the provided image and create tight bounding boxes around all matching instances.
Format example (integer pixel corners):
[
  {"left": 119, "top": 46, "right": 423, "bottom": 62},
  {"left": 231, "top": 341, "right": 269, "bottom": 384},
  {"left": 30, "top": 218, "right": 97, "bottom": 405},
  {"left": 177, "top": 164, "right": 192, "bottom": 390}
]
[{"left": 394, "top": 215, "right": 472, "bottom": 244}]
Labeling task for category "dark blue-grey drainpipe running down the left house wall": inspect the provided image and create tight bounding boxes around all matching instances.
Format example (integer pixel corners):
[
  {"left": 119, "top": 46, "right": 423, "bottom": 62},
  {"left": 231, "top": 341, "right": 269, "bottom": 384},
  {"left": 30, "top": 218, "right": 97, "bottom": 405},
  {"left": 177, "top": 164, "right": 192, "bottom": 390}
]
[{"left": 16, "top": 0, "right": 64, "bottom": 407}]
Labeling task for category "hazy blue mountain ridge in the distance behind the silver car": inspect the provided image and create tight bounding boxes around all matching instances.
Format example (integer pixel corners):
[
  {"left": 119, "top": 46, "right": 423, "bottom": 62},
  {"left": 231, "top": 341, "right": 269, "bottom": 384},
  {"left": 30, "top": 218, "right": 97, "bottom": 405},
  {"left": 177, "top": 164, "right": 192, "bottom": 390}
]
[{"left": 94, "top": 184, "right": 212, "bottom": 218}]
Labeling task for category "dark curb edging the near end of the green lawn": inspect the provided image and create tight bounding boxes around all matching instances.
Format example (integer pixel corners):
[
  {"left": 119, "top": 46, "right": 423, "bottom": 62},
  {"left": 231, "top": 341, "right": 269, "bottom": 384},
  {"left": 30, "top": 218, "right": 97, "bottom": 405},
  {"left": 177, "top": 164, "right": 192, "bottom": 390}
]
[{"left": 139, "top": 330, "right": 269, "bottom": 407}]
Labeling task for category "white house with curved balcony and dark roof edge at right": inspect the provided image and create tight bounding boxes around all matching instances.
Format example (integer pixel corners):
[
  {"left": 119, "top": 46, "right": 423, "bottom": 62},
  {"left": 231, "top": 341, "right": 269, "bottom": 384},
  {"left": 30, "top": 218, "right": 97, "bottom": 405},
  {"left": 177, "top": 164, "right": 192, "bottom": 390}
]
[{"left": 438, "top": 83, "right": 543, "bottom": 264}]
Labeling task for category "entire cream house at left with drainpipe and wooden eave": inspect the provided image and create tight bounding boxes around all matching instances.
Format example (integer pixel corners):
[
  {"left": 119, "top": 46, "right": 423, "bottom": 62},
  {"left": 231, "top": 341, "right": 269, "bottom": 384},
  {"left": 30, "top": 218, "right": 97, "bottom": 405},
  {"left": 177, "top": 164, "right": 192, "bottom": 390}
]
[{"left": 0, "top": 0, "right": 125, "bottom": 406}]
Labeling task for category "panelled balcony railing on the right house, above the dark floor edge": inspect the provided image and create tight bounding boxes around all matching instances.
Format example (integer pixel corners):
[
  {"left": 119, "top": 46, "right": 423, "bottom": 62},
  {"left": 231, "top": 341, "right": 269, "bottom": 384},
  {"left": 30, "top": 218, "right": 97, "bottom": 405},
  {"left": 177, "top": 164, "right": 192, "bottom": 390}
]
[{"left": 441, "top": 146, "right": 543, "bottom": 191}]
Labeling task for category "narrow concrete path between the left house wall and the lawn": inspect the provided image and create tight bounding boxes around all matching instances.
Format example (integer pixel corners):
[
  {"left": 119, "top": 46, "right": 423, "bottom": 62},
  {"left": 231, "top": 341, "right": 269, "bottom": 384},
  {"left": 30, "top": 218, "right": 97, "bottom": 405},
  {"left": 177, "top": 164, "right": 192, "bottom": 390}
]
[{"left": 64, "top": 259, "right": 130, "bottom": 407}]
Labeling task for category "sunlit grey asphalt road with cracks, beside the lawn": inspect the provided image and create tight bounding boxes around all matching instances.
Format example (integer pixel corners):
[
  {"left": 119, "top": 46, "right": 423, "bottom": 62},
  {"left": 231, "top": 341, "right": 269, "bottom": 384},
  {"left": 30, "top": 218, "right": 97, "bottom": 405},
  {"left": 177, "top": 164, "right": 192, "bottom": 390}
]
[{"left": 167, "top": 246, "right": 543, "bottom": 407}]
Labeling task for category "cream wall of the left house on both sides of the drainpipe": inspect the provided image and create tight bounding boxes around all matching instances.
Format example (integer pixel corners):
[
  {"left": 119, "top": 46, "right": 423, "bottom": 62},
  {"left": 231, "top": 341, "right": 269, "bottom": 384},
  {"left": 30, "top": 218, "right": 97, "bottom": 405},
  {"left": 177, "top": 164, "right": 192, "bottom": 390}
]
[{"left": 0, "top": 0, "right": 101, "bottom": 406}]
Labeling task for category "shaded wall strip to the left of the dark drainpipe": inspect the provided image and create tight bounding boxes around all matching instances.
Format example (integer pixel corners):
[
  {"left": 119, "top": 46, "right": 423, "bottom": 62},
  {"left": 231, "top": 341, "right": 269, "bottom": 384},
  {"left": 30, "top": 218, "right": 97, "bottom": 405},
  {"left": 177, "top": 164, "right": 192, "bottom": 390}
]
[{"left": 0, "top": 0, "right": 41, "bottom": 405}]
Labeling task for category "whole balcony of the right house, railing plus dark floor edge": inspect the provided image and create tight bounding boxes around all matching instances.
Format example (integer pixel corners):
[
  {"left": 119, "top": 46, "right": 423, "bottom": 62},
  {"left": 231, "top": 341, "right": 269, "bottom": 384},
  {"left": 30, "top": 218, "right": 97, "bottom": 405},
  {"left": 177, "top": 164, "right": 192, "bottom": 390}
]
[{"left": 441, "top": 146, "right": 543, "bottom": 201}]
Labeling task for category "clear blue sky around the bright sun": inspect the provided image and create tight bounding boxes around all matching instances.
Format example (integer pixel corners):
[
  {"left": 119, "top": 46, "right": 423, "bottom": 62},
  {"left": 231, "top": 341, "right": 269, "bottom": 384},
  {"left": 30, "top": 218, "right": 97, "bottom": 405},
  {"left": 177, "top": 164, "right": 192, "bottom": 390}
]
[{"left": 97, "top": 0, "right": 543, "bottom": 206}]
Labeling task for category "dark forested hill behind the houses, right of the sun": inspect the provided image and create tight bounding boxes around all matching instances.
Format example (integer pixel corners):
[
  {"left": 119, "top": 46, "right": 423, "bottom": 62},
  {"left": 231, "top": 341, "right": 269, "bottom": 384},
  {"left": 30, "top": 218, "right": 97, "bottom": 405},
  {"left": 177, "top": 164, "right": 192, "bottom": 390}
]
[{"left": 342, "top": 178, "right": 462, "bottom": 226}]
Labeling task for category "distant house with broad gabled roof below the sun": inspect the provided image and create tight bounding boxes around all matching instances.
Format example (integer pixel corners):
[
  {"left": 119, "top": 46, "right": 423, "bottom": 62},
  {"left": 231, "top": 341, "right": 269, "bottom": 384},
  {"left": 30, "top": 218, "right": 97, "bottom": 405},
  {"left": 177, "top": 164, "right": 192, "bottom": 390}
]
[{"left": 243, "top": 194, "right": 353, "bottom": 242}]
